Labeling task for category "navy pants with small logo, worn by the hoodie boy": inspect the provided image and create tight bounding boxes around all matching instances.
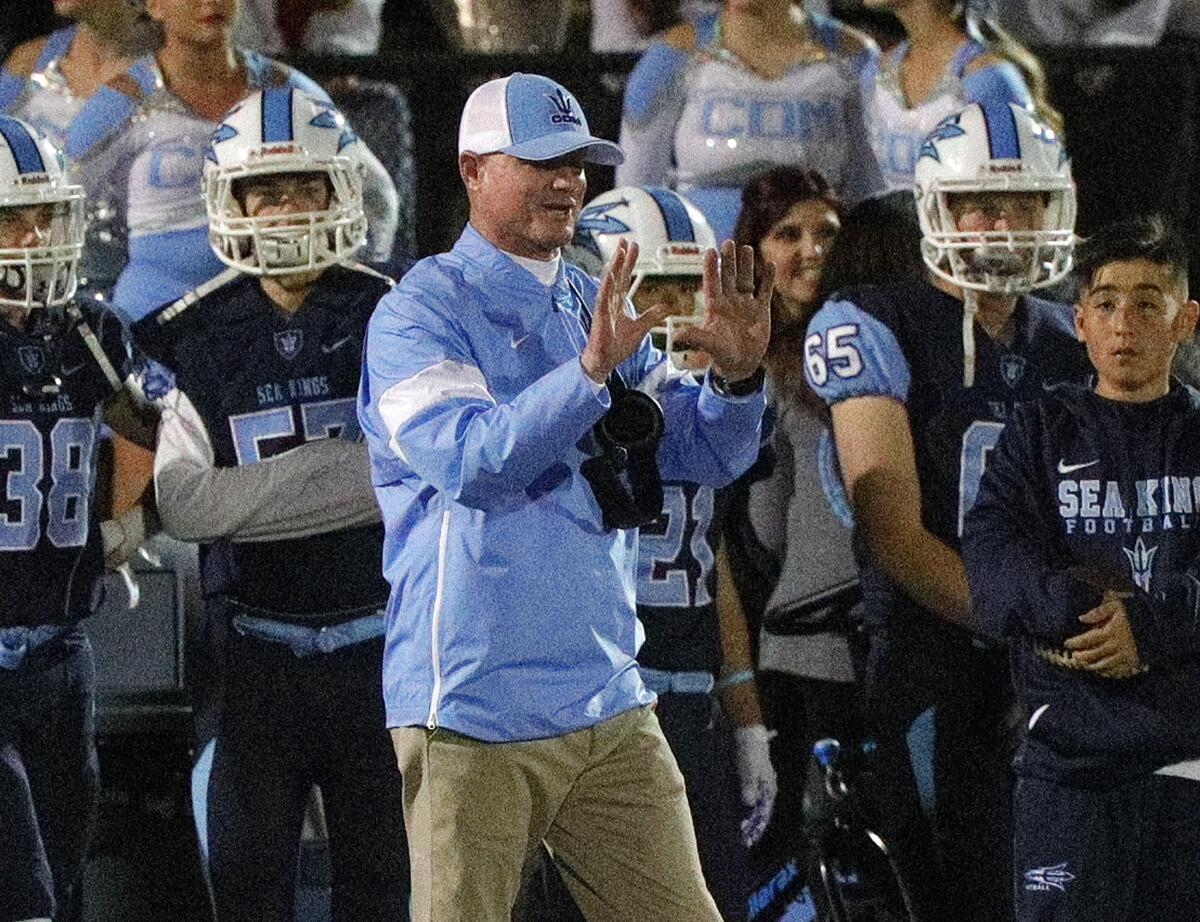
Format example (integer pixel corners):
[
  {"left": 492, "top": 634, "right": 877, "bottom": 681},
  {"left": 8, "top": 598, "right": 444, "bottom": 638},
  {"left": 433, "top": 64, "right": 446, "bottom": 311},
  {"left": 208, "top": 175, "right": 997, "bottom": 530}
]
[{"left": 1014, "top": 776, "right": 1200, "bottom": 922}]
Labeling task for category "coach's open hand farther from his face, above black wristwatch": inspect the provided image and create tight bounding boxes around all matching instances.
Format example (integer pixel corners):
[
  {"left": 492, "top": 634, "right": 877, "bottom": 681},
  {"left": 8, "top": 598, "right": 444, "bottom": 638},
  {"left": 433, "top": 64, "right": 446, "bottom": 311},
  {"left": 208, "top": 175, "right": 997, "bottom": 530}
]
[{"left": 674, "top": 240, "right": 775, "bottom": 382}]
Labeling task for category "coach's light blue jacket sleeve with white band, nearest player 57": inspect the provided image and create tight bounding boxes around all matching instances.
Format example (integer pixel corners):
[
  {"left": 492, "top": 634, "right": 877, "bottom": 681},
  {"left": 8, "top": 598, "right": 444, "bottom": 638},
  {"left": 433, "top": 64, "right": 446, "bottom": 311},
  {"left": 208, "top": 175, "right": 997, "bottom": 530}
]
[{"left": 359, "top": 280, "right": 611, "bottom": 509}]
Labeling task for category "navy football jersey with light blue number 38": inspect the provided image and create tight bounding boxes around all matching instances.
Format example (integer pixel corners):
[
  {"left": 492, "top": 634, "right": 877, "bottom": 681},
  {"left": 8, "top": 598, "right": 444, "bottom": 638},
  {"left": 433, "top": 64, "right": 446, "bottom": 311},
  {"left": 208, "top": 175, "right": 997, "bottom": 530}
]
[{"left": 0, "top": 307, "right": 128, "bottom": 627}]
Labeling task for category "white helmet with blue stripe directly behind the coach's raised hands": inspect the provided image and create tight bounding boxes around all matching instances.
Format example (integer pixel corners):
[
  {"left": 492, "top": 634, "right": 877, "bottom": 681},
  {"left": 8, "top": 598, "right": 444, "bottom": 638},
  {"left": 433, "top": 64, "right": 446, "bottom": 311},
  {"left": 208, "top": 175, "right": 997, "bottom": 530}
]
[{"left": 572, "top": 186, "right": 716, "bottom": 353}]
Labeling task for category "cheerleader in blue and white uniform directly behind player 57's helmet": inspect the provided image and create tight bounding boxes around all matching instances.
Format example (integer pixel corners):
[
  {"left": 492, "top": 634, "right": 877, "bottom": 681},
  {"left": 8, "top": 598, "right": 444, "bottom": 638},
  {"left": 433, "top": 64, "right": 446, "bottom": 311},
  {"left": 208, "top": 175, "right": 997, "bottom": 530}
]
[{"left": 67, "top": 0, "right": 398, "bottom": 322}]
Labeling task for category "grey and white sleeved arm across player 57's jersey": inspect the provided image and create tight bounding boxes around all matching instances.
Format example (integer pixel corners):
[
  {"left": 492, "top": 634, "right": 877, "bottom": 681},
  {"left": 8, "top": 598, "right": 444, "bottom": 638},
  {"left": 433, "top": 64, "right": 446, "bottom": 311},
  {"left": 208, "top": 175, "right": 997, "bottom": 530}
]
[{"left": 154, "top": 388, "right": 379, "bottom": 541}]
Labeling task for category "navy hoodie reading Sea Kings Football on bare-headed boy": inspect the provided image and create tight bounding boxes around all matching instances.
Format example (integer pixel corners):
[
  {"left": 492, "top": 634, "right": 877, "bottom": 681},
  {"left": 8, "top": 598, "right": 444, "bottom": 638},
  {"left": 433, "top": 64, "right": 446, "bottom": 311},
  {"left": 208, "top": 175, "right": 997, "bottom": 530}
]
[{"left": 962, "top": 384, "right": 1200, "bottom": 788}]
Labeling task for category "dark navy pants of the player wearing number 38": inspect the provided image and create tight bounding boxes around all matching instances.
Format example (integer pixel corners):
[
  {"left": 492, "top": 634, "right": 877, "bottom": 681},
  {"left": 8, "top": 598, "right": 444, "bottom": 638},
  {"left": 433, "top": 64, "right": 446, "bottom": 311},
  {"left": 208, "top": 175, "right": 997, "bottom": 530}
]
[{"left": 0, "top": 633, "right": 98, "bottom": 922}]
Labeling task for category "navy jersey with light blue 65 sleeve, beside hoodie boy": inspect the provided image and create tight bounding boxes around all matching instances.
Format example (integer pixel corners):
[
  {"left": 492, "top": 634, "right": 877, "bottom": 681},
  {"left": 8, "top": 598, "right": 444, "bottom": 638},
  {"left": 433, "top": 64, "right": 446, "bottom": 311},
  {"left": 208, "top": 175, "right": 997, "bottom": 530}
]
[{"left": 804, "top": 281, "right": 1091, "bottom": 625}]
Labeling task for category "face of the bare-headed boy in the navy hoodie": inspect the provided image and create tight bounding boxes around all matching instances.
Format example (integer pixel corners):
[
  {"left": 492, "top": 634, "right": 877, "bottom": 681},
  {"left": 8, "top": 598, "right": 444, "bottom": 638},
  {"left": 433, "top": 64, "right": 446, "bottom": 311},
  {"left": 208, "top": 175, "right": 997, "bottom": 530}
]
[{"left": 1075, "top": 259, "right": 1200, "bottom": 402}]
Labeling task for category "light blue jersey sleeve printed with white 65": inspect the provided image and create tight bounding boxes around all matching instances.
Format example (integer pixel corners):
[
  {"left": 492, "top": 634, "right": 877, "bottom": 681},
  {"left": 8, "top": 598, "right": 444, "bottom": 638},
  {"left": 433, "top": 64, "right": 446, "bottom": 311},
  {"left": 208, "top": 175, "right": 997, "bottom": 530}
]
[{"left": 804, "top": 299, "right": 912, "bottom": 405}]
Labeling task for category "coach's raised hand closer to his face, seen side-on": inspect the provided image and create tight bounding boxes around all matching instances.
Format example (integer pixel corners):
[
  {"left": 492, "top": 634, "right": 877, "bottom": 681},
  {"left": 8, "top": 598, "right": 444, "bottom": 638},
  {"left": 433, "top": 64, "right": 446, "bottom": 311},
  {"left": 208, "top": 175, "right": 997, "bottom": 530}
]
[{"left": 580, "top": 240, "right": 671, "bottom": 384}]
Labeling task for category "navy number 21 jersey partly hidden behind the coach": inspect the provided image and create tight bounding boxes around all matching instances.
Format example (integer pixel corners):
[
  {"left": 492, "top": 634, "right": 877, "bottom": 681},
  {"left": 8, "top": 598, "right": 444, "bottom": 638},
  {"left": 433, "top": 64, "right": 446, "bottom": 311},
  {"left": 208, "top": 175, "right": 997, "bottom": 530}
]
[{"left": 637, "top": 483, "right": 726, "bottom": 675}]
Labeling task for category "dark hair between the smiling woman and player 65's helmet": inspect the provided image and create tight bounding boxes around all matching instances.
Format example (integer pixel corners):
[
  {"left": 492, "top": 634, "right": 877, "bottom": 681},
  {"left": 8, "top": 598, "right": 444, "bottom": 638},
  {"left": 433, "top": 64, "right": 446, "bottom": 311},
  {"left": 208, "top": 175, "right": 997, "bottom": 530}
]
[{"left": 818, "top": 190, "right": 925, "bottom": 304}]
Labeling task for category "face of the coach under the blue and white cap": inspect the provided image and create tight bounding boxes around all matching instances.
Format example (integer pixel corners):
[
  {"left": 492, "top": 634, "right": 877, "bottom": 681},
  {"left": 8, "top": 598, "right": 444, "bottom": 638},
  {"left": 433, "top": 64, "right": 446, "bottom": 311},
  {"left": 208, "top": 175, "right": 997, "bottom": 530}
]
[{"left": 458, "top": 151, "right": 588, "bottom": 259}]
